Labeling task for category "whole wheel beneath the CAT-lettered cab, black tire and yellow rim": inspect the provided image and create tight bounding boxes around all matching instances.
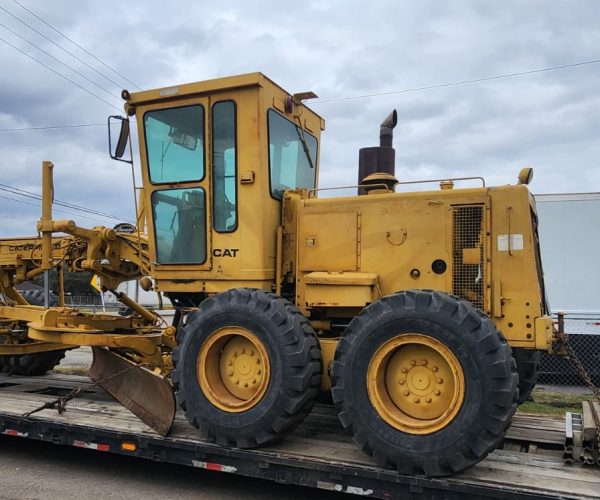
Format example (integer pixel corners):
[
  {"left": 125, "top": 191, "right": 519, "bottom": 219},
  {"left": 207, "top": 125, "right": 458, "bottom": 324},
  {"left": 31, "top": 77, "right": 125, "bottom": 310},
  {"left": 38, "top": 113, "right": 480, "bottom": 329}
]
[{"left": 172, "top": 288, "right": 322, "bottom": 448}]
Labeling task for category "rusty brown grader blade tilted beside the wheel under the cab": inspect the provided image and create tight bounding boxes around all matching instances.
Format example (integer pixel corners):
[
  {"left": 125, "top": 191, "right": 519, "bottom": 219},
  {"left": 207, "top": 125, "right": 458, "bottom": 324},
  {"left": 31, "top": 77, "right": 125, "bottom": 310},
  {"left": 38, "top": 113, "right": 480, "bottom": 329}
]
[{"left": 89, "top": 347, "right": 176, "bottom": 436}]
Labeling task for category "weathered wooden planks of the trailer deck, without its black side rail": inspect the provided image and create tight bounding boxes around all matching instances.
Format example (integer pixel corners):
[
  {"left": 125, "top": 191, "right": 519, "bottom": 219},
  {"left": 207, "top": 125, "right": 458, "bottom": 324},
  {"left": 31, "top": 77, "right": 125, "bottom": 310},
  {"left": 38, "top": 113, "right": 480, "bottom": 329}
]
[{"left": 0, "top": 375, "right": 600, "bottom": 498}]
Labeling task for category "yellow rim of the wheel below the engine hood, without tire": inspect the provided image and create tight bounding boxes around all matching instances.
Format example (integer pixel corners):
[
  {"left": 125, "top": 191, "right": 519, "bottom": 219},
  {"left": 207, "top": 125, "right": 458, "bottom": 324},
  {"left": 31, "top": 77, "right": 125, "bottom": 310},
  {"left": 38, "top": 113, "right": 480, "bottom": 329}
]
[{"left": 367, "top": 334, "right": 465, "bottom": 434}]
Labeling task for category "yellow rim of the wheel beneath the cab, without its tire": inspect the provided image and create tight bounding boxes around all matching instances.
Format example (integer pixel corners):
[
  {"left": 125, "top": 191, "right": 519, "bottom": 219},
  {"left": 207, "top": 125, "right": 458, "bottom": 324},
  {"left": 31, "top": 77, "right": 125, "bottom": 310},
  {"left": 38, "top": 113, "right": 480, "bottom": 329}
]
[{"left": 197, "top": 327, "right": 270, "bottom": 413}]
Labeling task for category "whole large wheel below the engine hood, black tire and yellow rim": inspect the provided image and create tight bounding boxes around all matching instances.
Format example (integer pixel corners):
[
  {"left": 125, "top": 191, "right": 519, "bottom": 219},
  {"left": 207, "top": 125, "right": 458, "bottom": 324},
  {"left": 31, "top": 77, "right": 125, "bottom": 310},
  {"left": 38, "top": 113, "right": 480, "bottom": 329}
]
[{"left": 332, "top": 290, "right": 518, "bottom": 476}]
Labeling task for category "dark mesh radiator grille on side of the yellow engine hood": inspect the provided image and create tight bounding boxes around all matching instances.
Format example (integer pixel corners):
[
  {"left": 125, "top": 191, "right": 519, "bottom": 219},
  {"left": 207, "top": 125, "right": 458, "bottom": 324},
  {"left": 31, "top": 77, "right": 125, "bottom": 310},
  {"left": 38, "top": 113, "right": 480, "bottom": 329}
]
[{"left": 452, "top": 205, "right": 485, "bottom": 310}]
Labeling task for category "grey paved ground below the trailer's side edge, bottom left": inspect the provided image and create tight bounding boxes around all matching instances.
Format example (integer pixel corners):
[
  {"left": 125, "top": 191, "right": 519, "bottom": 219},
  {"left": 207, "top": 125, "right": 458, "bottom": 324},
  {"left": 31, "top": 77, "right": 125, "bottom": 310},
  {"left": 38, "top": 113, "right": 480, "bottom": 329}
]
[{"left": 0, "top": 436, "right": 347, "bottom": 500}]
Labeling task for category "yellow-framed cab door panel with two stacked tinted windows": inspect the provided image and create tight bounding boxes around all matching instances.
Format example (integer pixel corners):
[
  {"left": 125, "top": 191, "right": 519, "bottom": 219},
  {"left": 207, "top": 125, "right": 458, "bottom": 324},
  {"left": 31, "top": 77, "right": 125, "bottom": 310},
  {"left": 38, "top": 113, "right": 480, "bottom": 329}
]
[{"left": 138, "top": 98, "right": 211, "bottom": 279}]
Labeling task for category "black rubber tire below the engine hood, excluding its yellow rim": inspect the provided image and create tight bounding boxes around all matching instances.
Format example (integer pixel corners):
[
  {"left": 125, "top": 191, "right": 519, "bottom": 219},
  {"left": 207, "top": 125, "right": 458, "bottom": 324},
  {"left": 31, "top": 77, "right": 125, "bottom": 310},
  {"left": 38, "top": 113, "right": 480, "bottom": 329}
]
[{"left": 332, "top": 290, "right": 518, "bottom": 476}]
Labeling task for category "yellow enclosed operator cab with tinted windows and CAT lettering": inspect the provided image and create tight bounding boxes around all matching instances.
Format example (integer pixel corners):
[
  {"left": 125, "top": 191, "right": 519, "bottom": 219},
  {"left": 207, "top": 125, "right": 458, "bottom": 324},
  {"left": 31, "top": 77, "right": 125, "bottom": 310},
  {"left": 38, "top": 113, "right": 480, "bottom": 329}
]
[{"left": 120, "top": 73, "right": 324, "bottom": 297}]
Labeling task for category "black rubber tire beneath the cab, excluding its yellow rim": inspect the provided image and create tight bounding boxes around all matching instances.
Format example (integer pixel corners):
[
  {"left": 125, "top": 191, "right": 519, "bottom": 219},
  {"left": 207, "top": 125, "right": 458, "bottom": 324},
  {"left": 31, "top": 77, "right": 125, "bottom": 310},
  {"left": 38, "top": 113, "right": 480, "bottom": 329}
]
[{"left": 172, "top": 288, "right": 322, "bottom": 448}]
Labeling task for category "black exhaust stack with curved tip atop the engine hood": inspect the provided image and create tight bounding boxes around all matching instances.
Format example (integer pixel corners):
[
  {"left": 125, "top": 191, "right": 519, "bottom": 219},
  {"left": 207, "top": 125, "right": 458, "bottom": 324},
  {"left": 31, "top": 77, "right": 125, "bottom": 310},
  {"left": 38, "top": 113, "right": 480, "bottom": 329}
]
[{"left": 358, "top": 110, "right": 398, "bottom": 195}]
